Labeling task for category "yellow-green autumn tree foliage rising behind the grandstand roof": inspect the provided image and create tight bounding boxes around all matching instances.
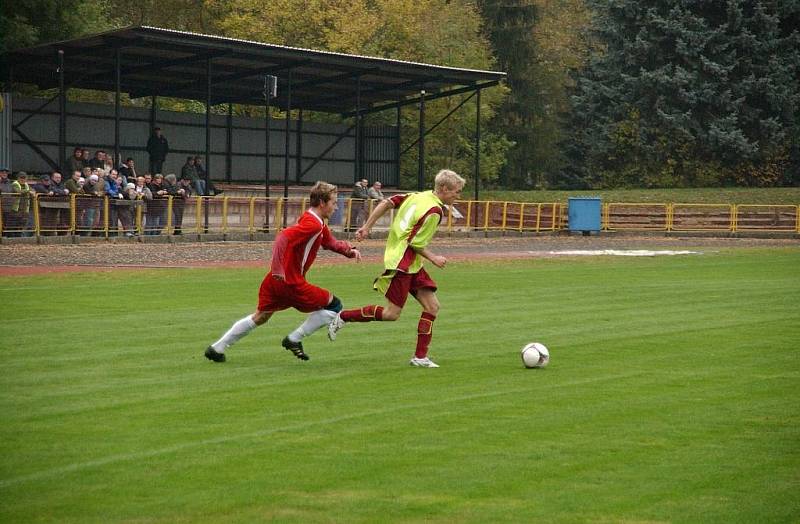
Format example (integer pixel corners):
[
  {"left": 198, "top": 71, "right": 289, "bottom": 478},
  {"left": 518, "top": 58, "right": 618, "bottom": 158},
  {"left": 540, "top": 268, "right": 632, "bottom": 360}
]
[{"left": 208, "top": 0, "right": 510, "bottom": 187}]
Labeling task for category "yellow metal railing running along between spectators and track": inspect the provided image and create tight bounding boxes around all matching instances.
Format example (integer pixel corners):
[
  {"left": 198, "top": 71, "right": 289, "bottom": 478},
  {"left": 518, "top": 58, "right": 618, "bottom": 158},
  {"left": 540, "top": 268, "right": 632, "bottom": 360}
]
[{"left": 0, "top": 194, "right": 800, "bottom": 237}]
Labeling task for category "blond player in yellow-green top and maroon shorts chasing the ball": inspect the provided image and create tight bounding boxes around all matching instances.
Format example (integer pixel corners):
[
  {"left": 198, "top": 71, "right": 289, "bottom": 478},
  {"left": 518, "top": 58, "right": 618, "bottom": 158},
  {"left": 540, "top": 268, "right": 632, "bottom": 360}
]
[{"left": 328, "top": 169, "right": 464, "bottom": 368}]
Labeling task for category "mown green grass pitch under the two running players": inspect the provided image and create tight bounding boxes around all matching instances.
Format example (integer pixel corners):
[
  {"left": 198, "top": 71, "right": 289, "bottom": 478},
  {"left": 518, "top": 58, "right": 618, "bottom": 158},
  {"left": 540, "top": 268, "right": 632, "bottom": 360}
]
[{"left": 0, "top": 248, "right": 800, "bottom": 523}]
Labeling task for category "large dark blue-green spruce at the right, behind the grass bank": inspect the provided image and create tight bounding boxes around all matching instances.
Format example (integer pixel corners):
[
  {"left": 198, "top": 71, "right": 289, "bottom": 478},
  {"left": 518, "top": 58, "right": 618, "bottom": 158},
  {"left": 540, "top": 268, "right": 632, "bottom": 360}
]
[{"left": 565, "top": 0, "right": 800, "bottom": 187}]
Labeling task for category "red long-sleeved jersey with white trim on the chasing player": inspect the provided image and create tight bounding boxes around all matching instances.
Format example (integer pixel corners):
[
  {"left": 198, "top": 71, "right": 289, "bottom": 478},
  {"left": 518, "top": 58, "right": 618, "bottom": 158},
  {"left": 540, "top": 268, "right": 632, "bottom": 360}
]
[{"left": 270, "top": 209, "right": 355, "bottom": 284}]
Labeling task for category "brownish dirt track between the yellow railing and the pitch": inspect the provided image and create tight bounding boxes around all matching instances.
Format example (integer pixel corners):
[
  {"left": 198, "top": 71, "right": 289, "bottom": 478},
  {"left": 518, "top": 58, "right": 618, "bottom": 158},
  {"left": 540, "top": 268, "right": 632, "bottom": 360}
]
[{"left": 0, "top": 235, "right": 800, "bottom": 275}]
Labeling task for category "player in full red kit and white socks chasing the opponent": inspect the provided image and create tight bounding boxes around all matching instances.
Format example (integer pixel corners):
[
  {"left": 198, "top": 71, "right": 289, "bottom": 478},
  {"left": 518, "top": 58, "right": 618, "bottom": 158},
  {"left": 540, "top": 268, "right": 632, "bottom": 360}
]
[{"left": 205, "top": 182, "right": 361, "bottom": 362}]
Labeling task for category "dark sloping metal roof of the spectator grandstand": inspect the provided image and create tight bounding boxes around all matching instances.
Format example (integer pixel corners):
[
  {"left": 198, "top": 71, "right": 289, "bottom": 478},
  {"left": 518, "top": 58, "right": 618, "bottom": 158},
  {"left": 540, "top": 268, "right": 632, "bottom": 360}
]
[{"left": 3, "top": 26, "right": 506, "bottom": 113}]
